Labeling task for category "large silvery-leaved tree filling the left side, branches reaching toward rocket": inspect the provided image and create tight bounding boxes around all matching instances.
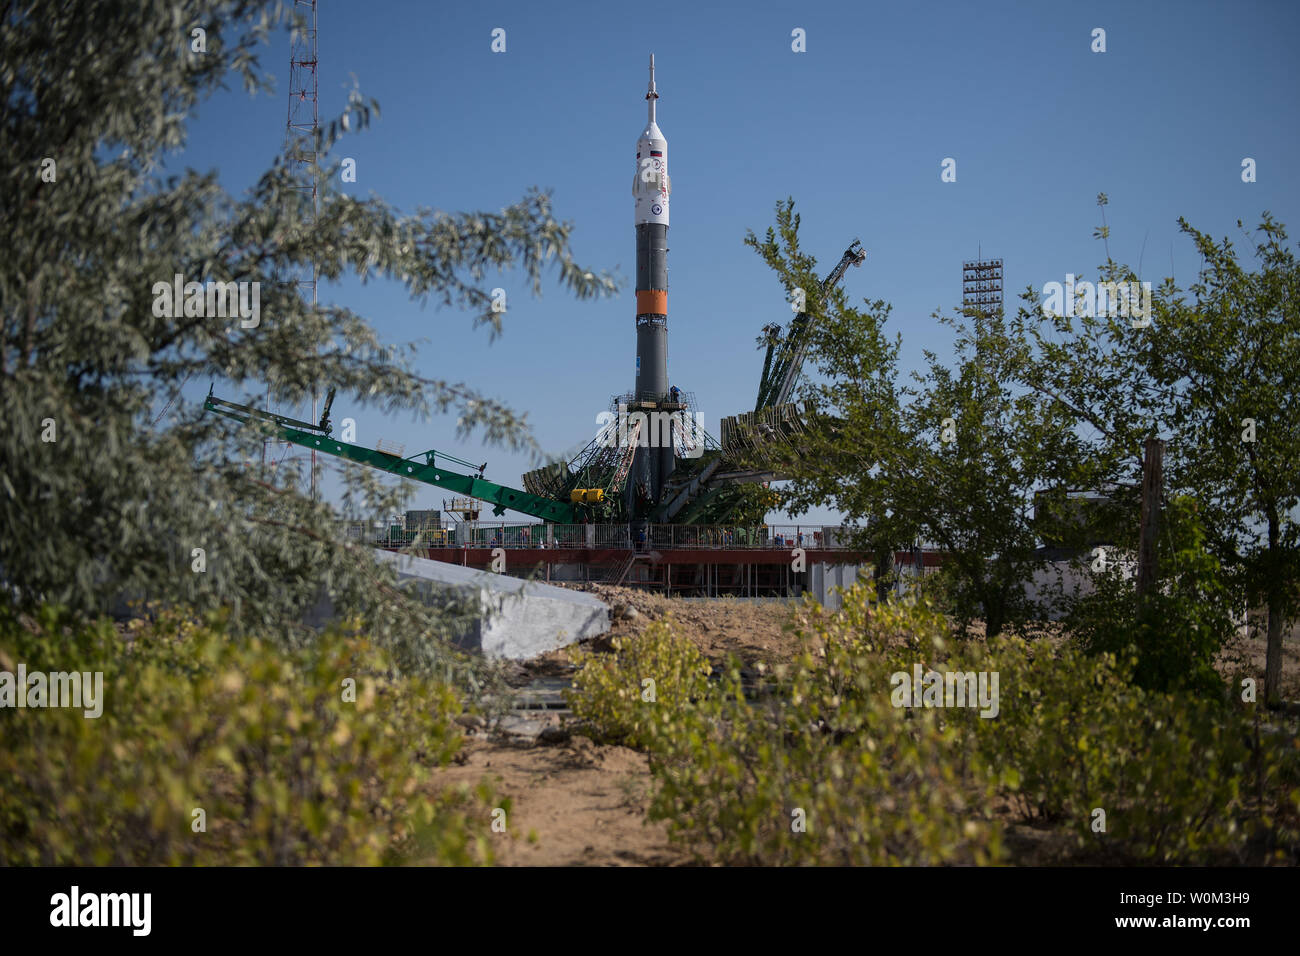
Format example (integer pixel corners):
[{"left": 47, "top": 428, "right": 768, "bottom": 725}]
[{"left": 0, "top": 0, "right": 615, "bottom": 665}]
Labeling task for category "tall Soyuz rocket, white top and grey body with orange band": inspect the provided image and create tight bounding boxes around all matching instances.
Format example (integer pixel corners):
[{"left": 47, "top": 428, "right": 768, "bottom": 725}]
[{"left": 628, "top": 53, "right": 681, "bottom": 522}]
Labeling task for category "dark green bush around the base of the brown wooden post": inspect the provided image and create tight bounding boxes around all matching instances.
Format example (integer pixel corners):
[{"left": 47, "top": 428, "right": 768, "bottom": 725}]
[{"left": 1066, "top": 498, "right": 1235, "bottom": 698}]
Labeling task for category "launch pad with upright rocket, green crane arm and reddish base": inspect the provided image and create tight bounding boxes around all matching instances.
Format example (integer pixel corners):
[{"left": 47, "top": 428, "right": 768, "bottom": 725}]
[{"left": 205, "top": 53, "right": 866, "bottom": 597}]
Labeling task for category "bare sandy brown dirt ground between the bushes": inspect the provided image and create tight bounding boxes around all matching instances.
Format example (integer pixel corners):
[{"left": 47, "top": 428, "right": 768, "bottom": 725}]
[{"left": 428, "top": 584, "right": 1300, "bottom": 866}]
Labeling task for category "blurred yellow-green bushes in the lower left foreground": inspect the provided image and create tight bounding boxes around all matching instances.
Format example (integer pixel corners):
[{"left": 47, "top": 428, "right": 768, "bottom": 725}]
[{"left": 0, "top": 609, "right": 504, "bottom": 866}]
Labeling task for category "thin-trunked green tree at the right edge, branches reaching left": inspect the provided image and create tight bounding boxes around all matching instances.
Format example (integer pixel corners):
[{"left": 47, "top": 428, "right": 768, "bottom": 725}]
[{"left": 1013, "top": 196, "right": 1300, "bottom": 704}]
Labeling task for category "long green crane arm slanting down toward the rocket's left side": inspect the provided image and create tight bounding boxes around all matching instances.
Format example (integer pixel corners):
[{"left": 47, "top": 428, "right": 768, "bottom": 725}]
[{"left": 203, "top": 388, "right": 588, "bottom": 524}]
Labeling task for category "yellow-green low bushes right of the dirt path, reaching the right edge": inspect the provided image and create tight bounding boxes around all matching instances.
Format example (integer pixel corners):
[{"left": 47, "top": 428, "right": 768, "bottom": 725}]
[{"left": 573, "top": 585, "right": 1300, "bottom": 865}]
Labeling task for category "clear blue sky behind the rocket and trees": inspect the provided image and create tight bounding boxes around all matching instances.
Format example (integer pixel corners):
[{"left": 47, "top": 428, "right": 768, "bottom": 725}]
[{"left": 178, "top": 0, "right": 1300, "bottom": 523}]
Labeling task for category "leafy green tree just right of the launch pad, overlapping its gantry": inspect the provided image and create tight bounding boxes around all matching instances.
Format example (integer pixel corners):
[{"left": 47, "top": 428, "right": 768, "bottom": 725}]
[{"left": 746, "top": 200, "right": 1076, "bottom": 635}]
